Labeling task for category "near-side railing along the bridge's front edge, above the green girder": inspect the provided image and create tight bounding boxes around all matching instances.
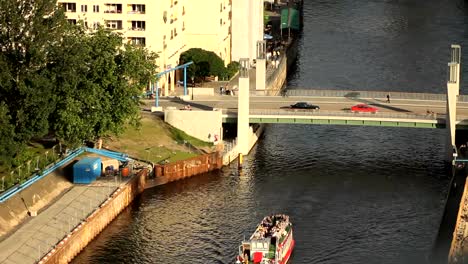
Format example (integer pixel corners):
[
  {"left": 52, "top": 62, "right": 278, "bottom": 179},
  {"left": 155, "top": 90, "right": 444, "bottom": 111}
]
[{"left": 223, "top": 109, "right": 446, "bottom": 121}]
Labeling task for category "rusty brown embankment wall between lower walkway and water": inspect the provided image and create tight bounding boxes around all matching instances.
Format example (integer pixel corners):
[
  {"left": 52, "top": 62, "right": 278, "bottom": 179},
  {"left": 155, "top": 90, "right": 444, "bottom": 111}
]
[{"left": 38, "top": 169, "right": 148, "bottom": 263}]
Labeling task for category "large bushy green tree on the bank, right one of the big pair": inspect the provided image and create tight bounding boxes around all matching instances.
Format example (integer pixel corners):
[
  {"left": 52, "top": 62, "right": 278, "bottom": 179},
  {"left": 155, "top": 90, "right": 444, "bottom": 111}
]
[{"left": 49, "top": 27, "right": 156, "bottom": 145}]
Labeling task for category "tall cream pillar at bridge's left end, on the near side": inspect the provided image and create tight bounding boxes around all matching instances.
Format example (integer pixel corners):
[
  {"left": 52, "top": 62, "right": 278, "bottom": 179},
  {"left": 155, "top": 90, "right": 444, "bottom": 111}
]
[{"left": 237, "top": 58, "right": 250, "bottom": 155}]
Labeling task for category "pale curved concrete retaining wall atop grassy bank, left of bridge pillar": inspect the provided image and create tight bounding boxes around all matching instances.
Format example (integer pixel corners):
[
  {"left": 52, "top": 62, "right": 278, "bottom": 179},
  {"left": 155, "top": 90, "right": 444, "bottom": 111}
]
[{"left": 164, "top": 110, "right": 223, "bottom": 142}]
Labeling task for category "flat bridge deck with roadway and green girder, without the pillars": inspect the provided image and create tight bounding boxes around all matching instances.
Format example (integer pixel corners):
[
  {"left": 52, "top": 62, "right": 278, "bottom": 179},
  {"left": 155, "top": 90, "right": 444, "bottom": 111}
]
[{"left": 155, "top": 92, "right": 468, "bottom": 129}]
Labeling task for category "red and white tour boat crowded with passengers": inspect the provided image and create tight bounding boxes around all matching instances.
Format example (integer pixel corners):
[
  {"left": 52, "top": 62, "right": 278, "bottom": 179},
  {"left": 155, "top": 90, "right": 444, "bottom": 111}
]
[{"left": 236, "top": 214, "right": 294, "bottom": 264}]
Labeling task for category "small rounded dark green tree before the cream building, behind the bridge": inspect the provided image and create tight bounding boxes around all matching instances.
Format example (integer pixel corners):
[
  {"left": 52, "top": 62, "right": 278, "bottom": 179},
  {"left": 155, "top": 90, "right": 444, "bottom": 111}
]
[{"left": 180, "top": 48, "right": 226, "bottom": 79}]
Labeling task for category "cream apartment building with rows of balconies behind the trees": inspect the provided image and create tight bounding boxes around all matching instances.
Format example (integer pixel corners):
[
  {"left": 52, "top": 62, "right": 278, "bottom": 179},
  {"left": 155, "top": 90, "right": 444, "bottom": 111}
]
[{"left": 58, "top": 0, "right": 231, "bottom": 94}]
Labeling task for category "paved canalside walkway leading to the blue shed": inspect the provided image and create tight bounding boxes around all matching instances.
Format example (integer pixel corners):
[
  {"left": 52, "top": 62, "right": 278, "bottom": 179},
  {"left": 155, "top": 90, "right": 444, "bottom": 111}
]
[{"left": 0, "top": 176, "right": 130, "bottom": 264}]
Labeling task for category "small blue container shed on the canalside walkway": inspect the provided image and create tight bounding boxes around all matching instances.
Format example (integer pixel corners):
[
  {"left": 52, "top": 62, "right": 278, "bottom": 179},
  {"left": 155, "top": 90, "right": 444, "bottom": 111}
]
[{"left": 73, "top": 157, "right": 101, "bottom": 184}]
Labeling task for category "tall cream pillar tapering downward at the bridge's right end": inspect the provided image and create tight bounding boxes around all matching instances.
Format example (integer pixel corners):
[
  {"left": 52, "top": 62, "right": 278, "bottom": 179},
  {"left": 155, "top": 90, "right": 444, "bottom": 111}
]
[{"left": 445, "top": 45, "right": 461, "bottom": 162}]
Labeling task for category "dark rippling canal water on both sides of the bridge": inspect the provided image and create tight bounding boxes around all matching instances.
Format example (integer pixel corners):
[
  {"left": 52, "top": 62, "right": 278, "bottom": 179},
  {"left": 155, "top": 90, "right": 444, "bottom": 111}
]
[{"left": 74, "top": 0, "right": 468, "bottom": 264}]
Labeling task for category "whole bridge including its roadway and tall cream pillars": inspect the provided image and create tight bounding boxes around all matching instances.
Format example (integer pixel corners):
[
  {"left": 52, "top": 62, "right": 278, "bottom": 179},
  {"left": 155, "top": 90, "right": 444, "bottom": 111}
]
[{"left": 156, "top": 45, "right": 460, "bottom": 161}]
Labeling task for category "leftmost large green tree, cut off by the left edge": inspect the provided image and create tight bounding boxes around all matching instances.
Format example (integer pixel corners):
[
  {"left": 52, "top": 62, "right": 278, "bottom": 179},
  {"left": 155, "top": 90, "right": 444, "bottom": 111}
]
[{"left": 0, "top": 0, "right": 66, "bottom": 145}]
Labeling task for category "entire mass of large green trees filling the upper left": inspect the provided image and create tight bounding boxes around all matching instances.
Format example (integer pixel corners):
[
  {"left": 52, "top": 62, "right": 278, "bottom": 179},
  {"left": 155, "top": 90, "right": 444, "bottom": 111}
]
[{"left": 0, "top": 0, "right": 156, "bottom": 163}]
